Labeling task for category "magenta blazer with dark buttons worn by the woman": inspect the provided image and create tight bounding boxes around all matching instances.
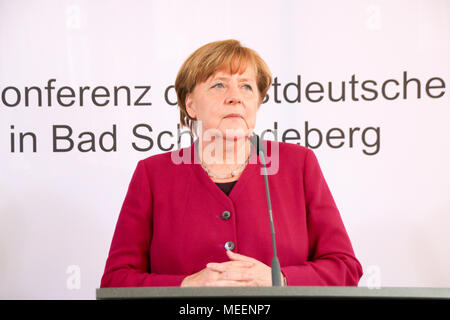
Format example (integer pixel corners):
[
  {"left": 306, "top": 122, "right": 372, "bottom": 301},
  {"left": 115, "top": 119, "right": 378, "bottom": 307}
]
[{"left": 101, "top": 140, "right": 362, "bottom": 287}]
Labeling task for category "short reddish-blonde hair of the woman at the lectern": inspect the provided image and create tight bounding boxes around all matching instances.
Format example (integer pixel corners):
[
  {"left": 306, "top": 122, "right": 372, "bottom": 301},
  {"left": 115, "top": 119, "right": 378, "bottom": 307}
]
[{"left": 175, "top": 40, "right": 272, "bottom": 132}]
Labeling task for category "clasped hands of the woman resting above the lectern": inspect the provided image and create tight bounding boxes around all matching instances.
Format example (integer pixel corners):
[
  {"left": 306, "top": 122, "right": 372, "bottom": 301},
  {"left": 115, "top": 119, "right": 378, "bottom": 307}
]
[{"left": 181, "top": 250, "right": 283, "bottom": 287}]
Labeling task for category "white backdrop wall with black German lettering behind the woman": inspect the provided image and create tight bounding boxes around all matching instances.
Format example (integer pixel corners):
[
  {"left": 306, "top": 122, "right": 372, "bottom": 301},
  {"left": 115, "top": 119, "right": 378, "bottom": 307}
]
[{"left": 0, "top": 0, "right": 450, "bottom": 299}]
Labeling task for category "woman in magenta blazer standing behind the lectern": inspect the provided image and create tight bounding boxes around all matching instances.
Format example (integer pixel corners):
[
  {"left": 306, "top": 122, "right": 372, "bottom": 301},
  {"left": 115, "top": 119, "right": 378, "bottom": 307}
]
[{"left": 101, "top": 40, "right": 362, "bottom": 287}]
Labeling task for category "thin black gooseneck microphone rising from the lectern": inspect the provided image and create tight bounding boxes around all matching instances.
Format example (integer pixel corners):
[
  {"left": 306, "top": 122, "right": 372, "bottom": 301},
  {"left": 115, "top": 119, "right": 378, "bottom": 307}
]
[{"left": 249, "top": 133, "right": 281, "bottom": 287}]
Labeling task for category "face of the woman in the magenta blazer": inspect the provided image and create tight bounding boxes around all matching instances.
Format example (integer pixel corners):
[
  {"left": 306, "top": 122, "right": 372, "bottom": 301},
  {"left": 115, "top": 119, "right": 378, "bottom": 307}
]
[{"left": 186, "top": 67, "right": 260, "bottom": 138}]
